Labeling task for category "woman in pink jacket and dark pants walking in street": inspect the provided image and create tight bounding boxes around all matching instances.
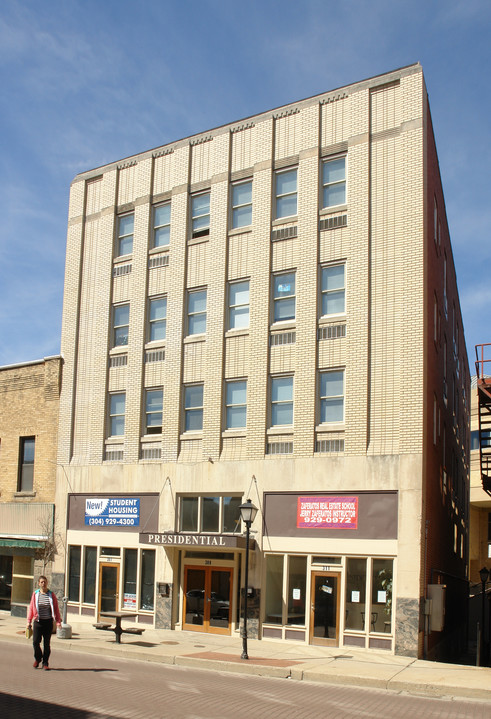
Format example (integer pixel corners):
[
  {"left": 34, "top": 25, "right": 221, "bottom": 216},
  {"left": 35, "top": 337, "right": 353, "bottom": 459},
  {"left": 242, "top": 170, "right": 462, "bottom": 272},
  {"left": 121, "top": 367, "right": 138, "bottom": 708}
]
[{"left": 27, "top": 574, "right": 61, "bottom": 669}]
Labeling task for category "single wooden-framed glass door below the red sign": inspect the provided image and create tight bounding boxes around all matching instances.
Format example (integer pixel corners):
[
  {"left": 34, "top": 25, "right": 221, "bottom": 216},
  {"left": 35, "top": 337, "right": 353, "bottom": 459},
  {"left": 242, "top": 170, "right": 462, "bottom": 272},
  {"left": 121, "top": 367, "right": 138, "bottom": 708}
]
[{"left": 310, "top": 572, "right": 339, "bottom": 647}]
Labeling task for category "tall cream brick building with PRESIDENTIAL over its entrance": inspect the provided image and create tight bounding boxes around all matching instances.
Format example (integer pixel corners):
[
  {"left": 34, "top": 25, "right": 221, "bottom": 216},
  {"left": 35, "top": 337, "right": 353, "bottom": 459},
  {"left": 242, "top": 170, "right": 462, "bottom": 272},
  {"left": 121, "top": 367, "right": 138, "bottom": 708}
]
[{"left": 54, "top": 64, "right": 469, "bottom": 656}]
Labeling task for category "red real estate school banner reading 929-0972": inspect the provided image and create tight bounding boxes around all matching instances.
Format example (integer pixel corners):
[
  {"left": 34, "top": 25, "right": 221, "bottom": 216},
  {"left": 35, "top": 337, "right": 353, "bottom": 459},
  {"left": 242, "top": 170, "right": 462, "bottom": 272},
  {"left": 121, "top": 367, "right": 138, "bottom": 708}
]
[{"left": 297, "top": 497, "right": 358, "bottom": 529}]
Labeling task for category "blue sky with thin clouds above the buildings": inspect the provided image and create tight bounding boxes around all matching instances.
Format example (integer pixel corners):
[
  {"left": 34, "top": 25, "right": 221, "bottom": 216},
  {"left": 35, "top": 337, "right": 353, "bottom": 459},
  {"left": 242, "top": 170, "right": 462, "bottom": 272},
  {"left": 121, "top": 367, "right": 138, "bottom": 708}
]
[{"left": 0, "top": 0, "right": 491, "bottom": 372}]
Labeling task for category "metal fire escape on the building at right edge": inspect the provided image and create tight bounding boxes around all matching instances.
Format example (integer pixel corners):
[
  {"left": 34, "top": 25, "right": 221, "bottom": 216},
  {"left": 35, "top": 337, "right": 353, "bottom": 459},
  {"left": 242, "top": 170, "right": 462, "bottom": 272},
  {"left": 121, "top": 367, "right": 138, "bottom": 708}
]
[{"left": 476, "top": 342, "right": 491, "bottom": 496}]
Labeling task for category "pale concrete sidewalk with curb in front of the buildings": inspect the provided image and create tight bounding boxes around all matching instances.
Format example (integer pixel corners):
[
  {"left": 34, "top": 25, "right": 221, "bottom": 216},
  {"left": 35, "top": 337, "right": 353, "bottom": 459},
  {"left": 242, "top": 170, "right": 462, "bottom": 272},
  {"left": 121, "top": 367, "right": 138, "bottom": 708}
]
[{"left": 0, "top": 612, "right": 491, "bottom": 704}]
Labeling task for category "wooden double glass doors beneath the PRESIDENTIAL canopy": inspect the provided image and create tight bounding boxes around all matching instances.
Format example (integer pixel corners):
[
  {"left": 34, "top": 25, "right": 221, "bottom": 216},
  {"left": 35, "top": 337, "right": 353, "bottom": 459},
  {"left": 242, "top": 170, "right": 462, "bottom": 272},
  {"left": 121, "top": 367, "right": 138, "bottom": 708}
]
[{"left": 183, "top": 567, "right": 233, "bottom": 634}]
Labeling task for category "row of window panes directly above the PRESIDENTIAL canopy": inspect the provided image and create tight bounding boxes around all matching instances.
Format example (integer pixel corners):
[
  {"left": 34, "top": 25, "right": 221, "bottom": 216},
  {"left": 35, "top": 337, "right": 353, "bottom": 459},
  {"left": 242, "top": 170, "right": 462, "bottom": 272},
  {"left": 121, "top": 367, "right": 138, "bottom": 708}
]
[{"left": 179, "top": 495, "right": 242, "bottom": 534}]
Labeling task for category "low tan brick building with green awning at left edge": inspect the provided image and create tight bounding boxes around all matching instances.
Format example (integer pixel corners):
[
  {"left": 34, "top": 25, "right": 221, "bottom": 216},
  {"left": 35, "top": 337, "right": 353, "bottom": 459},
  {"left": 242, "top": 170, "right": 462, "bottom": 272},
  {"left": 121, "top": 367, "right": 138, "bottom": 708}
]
[{"left": 0, "top": 357, "right": 61, "bottom": 616}]
